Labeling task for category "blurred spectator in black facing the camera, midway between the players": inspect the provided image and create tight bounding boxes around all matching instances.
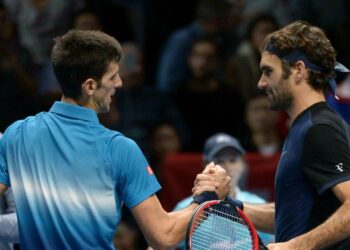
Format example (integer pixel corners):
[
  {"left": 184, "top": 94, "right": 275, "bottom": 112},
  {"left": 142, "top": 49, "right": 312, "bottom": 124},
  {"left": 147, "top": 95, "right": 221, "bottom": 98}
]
[{"left": 174, "top": 38, "right": 243, "bottom": 151}]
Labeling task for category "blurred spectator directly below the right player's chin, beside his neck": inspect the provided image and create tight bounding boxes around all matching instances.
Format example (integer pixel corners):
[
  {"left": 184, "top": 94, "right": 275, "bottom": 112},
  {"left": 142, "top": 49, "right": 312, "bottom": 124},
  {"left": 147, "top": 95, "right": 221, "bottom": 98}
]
[{"left": 243, "top": 91, "right": 283, "bottom": 156}]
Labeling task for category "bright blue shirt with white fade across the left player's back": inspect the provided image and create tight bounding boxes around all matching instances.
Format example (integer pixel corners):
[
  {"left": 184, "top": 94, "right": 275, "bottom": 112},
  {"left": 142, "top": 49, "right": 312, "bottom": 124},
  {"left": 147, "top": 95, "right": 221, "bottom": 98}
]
[{"left": 0, "top": 102, "right": 160, "bottom": 250}]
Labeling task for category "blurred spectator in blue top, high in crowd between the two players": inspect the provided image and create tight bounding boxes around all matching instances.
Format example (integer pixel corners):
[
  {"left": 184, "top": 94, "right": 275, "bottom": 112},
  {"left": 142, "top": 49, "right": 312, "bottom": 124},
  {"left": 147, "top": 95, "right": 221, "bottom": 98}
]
[{"left": 157, "top": 0, "right": 232, "bottom": 92}]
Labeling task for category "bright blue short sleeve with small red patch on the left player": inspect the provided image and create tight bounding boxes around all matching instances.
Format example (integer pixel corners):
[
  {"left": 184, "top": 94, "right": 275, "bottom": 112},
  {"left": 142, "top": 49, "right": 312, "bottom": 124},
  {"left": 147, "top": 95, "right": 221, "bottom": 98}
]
[{"left": 110, "top": 136, "right": 160, "bottom": 208}]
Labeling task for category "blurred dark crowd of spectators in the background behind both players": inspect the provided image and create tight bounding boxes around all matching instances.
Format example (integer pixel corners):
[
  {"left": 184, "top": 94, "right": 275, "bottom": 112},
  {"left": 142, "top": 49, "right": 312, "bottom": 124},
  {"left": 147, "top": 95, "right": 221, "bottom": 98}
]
[{"left": 0, "top": 0, "right": 350, "bottom": 250}]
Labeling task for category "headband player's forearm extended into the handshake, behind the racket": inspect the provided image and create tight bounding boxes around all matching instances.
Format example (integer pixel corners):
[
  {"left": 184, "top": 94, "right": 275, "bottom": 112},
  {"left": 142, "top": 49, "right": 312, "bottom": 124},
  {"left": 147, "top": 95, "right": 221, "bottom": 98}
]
[{"left": 243, "top": 203, "right": 275, "bottom": 233}]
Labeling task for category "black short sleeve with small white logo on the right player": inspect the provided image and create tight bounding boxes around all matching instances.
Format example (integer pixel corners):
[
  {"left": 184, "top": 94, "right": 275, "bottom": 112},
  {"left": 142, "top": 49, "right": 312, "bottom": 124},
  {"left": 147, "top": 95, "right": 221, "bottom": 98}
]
[{"left": 301, "top": 124, "right": 350, "bottom": 194}]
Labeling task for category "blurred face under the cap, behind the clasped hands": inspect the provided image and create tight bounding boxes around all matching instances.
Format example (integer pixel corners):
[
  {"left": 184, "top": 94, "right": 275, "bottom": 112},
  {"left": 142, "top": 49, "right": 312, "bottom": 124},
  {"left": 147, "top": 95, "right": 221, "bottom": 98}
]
[{"left": 213, "top": 148, "right": 244, "bottom": 188}]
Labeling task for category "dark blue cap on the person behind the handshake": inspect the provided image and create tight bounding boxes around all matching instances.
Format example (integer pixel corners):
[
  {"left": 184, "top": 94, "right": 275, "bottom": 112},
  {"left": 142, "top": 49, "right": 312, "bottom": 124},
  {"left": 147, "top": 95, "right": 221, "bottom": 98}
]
[{"left": 203, "top": 133, "right": 245, "bottom": 164}]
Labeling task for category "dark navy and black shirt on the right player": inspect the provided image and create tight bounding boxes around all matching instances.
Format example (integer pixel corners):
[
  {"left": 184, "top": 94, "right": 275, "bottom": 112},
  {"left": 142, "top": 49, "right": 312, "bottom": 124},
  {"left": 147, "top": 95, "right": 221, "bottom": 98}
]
[{"left": 275, "top": 102, "right": 350, "bottom": 250}]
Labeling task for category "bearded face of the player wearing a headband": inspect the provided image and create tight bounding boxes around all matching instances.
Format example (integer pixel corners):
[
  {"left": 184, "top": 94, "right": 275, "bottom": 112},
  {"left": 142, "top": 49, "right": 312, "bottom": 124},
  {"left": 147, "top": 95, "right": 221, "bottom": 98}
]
[{"left": 258, "top": 51, "right": 294, "bottom": 111}]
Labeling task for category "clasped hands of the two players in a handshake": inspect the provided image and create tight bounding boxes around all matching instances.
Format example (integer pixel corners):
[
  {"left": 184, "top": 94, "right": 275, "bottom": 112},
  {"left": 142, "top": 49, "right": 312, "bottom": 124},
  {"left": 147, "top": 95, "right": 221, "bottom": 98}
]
[{"left": 192, "top": 163, "right": 231, "bottom": 200}]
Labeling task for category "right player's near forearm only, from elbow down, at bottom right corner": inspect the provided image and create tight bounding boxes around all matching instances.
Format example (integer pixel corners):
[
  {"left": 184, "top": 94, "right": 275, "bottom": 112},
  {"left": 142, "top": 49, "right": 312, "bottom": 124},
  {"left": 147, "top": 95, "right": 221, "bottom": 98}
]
[{"left": 290, "top": 201, "right": 350, "bottom": 249}]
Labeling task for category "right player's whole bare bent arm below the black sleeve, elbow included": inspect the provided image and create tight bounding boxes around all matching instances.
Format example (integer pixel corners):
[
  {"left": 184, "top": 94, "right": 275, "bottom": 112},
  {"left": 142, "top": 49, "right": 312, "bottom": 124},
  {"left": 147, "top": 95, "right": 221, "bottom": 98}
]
[{"left": 269, "top": 181, "right": 350, "bottom": 250}]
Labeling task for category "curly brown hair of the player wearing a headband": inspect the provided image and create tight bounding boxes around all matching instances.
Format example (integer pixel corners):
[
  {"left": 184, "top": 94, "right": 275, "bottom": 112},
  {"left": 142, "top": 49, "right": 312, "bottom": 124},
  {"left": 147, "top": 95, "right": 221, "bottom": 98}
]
[{"left": 261, "top": 21, "right": 336, "bottom": 92}]
